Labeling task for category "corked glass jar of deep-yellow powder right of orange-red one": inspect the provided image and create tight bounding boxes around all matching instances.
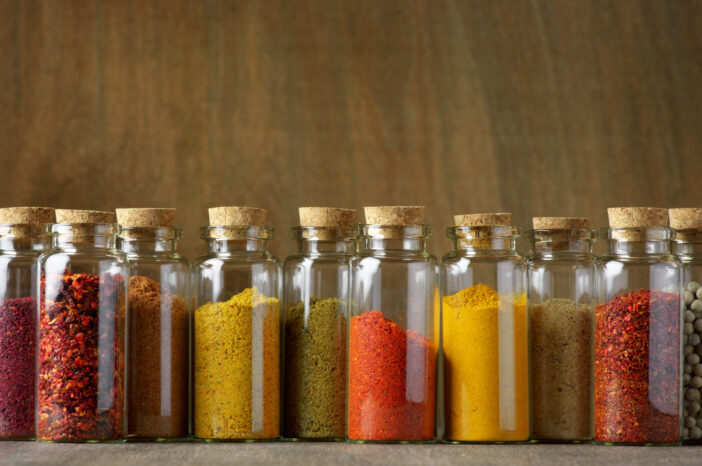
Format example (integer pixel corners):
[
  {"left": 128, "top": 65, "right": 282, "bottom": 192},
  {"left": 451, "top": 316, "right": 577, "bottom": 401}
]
[{"left": 441, "top": 214, "right": 529, "bottom": 442}]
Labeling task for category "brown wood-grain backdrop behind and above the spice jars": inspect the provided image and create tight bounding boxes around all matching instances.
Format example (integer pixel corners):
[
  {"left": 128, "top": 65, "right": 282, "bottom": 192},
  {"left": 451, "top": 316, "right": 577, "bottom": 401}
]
[{"left": 0, "top": 0, "right": 702, "bottom": 259}]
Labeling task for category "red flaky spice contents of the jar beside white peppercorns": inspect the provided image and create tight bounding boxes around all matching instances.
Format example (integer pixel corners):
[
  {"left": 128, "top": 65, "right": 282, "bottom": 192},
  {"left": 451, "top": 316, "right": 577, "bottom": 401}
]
[{"left": 595, "top": 290, "right": 681, "bottom": 443}]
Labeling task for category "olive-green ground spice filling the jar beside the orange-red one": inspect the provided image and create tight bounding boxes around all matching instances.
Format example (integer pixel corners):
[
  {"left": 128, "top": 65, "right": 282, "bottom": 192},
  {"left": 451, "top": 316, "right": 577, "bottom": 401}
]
[{"left": 285, "top": 298, "right": 346, "bottom": 438}]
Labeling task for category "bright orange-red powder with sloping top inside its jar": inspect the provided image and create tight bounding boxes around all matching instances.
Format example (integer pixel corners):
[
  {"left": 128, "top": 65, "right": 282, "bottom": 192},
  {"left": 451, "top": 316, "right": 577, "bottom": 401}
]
[{"left": 348, "top": 311, "right": 436, "bottom": 441}]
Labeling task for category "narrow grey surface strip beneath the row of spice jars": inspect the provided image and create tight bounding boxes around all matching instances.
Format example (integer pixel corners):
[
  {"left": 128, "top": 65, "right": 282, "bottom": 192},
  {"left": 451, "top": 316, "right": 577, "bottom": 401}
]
[{"left": 0, "top": 442, "right": 702, "bottom": 466}]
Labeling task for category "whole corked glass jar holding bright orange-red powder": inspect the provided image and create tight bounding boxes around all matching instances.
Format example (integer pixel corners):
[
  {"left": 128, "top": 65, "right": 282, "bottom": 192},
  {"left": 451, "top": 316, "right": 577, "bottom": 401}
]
[{"left": 347, "top": 207, "right": 439, "bottom": 442}]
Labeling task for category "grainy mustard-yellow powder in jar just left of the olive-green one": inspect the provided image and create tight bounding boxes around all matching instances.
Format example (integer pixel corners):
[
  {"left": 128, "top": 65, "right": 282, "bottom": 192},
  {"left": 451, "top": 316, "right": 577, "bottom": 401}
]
[{"left": 194, "top": 288, "right": 280, "bottom": 439}]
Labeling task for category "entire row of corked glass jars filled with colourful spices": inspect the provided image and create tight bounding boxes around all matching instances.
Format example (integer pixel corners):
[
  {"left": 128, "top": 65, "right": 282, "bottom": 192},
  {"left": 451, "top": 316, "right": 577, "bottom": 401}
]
[{"left": 0, "top": 207, "right": 702, "bottom": 443}]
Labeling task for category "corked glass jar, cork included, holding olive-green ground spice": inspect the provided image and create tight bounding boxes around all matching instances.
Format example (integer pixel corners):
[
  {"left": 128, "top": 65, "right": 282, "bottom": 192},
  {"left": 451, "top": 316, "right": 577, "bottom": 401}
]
[{"left": 284, "top": 207, "right": 356, "bottom": 440}]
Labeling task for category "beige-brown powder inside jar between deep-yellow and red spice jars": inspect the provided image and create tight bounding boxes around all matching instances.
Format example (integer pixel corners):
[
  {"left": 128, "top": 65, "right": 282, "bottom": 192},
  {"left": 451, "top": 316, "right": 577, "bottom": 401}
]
[{"left": 531, "top": 298, "right": 594, "bottom": 440}]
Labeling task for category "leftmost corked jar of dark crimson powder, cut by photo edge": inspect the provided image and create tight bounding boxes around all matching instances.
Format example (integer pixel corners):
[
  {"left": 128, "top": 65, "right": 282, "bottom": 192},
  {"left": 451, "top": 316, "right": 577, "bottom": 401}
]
[{"left": 0, "top": 207, "right": 55, "bottom": 440}]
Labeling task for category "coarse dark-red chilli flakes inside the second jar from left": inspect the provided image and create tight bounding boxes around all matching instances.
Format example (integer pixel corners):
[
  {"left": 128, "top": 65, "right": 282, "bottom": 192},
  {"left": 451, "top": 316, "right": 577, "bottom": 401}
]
[{"left": 37, "top": 272, "right": 125, "bottom": 440}]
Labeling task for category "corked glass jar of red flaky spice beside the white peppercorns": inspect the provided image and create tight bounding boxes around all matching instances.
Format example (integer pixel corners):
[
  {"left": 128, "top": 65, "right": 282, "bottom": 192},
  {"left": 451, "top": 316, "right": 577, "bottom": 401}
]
[{"left": 594, "top": 207, "right": 682, "bottom": 444}]
